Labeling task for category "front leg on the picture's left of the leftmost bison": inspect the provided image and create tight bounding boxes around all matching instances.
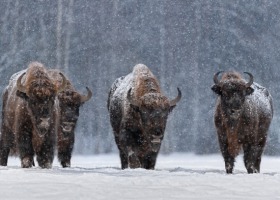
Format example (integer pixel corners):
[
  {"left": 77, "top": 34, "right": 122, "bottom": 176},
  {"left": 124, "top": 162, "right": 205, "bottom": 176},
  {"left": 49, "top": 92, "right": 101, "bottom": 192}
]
[{"left": 17, "top": 132, "right": 34, "bottom": 168}]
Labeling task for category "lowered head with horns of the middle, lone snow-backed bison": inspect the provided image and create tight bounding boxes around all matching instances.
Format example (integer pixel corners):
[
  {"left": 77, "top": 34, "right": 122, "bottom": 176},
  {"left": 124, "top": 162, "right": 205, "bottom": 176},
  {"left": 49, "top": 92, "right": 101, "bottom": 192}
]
[{"left": 127, "top": 88, "right": 182, "bottom": 152}]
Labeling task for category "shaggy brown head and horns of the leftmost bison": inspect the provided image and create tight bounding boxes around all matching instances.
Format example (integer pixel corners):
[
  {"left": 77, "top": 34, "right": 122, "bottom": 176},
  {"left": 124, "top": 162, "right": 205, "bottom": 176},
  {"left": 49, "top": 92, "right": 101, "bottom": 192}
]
[{"left": 17, "top": 71, "right": 66, "bottom": 136}]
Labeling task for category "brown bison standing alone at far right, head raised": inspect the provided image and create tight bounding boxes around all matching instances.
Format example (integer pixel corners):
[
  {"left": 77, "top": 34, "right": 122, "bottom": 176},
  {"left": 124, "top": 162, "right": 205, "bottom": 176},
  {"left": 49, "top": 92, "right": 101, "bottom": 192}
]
[{"left": 211, "top": 72, "right": 273, "bottom": 173}]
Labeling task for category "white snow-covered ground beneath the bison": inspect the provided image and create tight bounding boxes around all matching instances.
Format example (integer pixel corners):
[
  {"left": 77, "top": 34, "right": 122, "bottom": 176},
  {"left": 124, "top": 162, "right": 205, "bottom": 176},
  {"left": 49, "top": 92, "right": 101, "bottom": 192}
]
[{"left": 0, "top": 154, "right": 280, "bottom": 200}]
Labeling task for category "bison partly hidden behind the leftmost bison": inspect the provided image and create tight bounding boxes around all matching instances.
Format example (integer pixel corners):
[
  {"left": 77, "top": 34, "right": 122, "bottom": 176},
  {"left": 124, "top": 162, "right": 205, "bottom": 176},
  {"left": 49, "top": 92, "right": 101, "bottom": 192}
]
[{"left": 49, "top": 69, "right": 92, "bottom": 167}]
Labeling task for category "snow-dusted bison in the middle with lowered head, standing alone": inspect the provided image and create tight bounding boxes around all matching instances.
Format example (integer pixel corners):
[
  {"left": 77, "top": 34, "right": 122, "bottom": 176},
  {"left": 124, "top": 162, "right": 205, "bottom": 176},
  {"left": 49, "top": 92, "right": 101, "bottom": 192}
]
[{"left": 107, "top": 64, "right": 181, "bottom": 169}]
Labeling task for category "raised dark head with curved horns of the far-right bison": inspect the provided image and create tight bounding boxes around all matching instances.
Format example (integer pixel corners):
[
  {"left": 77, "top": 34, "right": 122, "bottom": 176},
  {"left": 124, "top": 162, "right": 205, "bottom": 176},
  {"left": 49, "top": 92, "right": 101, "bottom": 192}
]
[{"left": 211, "top": 72, "right": 254, "bottom": 117}]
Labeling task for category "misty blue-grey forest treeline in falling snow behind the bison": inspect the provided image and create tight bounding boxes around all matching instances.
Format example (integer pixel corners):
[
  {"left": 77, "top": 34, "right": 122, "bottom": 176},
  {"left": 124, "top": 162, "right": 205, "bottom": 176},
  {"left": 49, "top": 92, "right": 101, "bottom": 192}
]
[{"left": 0, "top": 0, "right": 280, "bottom": 155}]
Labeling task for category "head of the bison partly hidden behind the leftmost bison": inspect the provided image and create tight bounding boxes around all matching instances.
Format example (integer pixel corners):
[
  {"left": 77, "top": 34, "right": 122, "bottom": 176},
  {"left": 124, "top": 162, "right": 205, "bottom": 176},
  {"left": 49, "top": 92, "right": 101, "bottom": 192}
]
[{"left": 58, "top": 85, "right": 92, "bottom": 137}]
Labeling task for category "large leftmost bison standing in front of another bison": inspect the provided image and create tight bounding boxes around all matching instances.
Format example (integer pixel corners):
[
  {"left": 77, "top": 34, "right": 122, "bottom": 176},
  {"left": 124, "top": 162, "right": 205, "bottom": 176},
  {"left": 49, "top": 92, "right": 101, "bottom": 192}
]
[{"left": 0, "top": 62, "right": 66, "bottom": 168}]
